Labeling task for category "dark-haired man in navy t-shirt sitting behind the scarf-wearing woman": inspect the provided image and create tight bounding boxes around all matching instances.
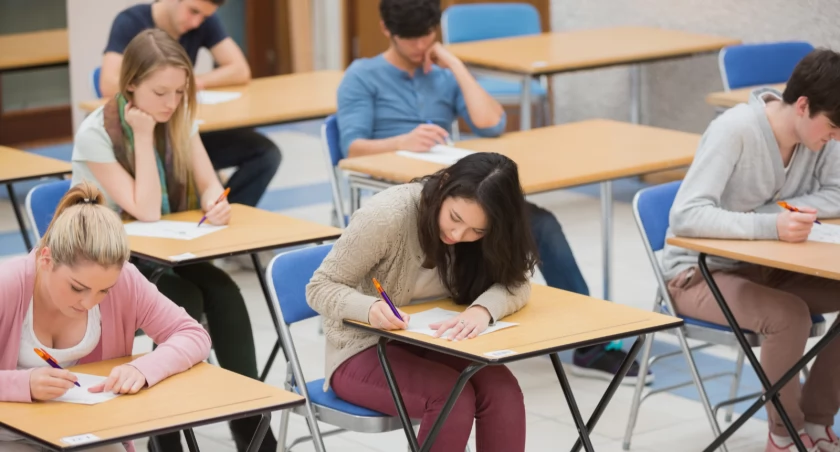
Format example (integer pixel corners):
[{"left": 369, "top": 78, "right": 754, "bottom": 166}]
[{"left": 99, "top": 0, "right": 280, "bottom": 212}]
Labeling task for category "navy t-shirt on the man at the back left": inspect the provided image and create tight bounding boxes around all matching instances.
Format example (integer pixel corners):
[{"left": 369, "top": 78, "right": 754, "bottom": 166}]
[{"left": 105, "top": 3, "right": 227, "bottom": 64}]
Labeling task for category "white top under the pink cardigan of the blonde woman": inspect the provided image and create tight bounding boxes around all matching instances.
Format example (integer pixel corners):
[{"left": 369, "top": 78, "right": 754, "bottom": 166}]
[{"left": 0, "top": 300, "right": 102, "bottom": 442}]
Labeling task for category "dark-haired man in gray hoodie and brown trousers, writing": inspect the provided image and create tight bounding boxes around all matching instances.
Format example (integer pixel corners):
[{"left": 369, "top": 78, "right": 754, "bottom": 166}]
[{"left": 662, "top": 49, "right": 840, "bottom": 452}]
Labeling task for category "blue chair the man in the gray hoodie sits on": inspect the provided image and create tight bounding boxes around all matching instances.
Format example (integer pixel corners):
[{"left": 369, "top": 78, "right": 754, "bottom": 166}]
[{"left": 624, "top": 181, "right": 825, "bottom": 450}]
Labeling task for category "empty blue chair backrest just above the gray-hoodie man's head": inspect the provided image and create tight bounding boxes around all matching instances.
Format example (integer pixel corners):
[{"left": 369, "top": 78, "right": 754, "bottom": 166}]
[{"left": 718, "top": 41, "right": 814, "bottom": 91}]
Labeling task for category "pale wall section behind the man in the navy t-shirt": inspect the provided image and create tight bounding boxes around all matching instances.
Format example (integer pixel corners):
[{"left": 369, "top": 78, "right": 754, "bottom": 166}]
[{"left": 66, "top": 0, "right": 212, "bottom": 130}]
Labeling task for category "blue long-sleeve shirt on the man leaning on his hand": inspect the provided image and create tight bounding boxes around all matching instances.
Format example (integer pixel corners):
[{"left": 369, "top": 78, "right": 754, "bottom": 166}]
[{"left": 337, "top": 55, "right": 506, "bottom": 157}]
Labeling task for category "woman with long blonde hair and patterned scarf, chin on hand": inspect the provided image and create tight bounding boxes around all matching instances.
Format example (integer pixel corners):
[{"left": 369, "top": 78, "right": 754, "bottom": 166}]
[{"left": 72, "top": 29, "right": 277, "bottom": 452}]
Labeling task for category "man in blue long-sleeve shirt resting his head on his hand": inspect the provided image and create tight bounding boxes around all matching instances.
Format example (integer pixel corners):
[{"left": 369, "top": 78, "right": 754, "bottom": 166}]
[{"left": 337, "top": 0, "right": 653, "bottom": 384}]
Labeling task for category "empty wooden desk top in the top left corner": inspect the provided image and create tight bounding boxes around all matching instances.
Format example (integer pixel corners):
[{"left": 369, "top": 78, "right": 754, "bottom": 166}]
[{"left": 0, "top": 29, "right": 70, "bottom": 71}]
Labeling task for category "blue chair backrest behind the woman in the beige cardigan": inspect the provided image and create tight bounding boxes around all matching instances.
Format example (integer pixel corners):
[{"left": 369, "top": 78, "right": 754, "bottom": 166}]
[{"left": 266, "top": 243, "right": 332, "bottom": 325}]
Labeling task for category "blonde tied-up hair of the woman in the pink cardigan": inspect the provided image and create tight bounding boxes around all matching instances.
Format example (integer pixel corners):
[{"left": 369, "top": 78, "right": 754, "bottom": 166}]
[{"left": 38, "top": 182, "right": 131, "bottom": 267}]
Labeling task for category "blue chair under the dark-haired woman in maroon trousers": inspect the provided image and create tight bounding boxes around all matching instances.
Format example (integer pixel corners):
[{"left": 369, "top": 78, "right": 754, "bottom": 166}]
[{"left": 266, "top": 244, "right": 410, "bottom": 451}]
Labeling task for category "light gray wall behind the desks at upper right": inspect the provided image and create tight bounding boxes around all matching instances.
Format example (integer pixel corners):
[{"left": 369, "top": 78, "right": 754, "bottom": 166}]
[{"left": 551, "top": 0, "right": 840, "bottom": 132}]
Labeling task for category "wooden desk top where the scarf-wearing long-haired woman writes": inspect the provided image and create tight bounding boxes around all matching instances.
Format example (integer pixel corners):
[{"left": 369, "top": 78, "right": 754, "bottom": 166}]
[{"left": 128, "top": 204, "right": 341, "bottom": 267}]
